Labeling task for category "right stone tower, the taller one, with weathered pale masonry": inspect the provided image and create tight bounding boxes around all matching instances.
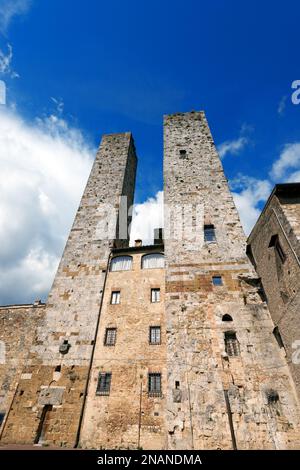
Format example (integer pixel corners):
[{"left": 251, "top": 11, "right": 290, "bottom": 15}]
[{"left": 164, "top": 112, "right": 300, "bottom": 449}]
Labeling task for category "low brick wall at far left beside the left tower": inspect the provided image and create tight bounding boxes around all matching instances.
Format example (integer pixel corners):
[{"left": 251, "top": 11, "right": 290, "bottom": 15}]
[{"left": 0, "top": 303, "right": 45, "bottom": 433}]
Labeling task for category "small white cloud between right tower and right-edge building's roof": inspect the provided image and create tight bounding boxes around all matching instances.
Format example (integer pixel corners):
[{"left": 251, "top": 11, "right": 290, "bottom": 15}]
[{"left": 231, "top": 176, "right": 272, "bottom": 235}]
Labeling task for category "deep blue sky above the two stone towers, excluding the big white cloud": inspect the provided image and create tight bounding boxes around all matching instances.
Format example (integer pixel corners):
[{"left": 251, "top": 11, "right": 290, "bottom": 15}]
[{"left": 0, "top": 0, "right": 300, "bottom": 301}]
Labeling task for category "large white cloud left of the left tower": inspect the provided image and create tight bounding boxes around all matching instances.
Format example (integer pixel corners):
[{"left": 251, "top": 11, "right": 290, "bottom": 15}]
[{"left": 0, "top": 108, "right": 95, "bottom": 304}]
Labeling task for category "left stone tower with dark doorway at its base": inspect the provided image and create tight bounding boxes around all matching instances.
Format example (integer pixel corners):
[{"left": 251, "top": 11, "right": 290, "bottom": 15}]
[{"left": 2, "top": 133, "right": 136, "bottom": 447}]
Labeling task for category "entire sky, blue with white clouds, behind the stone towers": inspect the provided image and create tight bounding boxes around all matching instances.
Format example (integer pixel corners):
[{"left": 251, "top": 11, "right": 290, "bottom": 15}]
[{"left": 0, "top": 0, "right": 300, "bottom": 304}]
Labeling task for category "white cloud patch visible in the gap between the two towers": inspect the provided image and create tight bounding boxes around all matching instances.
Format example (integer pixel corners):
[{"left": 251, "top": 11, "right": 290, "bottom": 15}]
[{"left": 130, "top": 191, "right": 163, "bottom": 245}]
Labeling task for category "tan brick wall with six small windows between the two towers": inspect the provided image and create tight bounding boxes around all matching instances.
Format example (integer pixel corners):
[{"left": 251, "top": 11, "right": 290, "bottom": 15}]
[{"left": 80, "top": 249, "right": 167, "bottom": 449}]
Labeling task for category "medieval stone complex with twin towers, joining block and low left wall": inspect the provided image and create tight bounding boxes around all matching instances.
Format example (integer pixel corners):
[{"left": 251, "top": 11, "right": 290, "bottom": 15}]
[{"left": 0, "top": 112, "right": 300, "bottom": 449}]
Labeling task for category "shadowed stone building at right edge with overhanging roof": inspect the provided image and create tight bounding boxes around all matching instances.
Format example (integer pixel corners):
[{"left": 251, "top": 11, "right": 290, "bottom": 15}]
[{"left": 248, "top": 183, "right": 300, "bottom": 397}]
